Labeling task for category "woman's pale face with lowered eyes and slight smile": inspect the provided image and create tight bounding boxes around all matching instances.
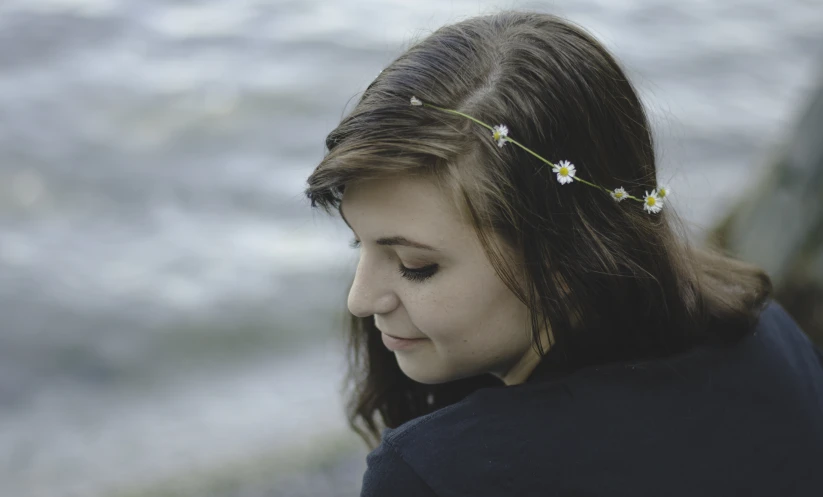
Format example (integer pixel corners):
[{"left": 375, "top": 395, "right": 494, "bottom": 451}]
[{"left": 341, "top": 173, "right": 547, "bottom": 385}]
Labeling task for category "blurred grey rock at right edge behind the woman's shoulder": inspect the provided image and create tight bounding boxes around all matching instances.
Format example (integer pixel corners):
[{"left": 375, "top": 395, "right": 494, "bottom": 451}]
[{"left": 709, "top": 60, "right": 823, "bottom": 346}]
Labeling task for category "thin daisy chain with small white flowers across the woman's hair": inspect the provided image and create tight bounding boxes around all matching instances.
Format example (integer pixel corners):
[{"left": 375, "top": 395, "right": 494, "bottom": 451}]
[{"left": 411, "top": 97, "right": 671, "bottom": 214}]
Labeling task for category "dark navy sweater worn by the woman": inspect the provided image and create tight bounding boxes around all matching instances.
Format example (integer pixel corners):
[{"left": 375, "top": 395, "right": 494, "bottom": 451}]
[{"left": 360, "top": 301, "right": 823, "bottom": 497}]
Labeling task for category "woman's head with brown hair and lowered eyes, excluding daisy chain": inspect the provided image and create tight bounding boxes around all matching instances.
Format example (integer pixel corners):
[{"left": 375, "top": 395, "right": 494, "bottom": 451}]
[{"left": 306, "top": 12, "right": 768, "bottom": 448}]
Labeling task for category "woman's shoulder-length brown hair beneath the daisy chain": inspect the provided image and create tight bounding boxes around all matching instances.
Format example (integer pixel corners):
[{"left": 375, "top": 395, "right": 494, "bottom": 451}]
[{"left": 305, "top": 11, "right": 772, "bottom": 448}]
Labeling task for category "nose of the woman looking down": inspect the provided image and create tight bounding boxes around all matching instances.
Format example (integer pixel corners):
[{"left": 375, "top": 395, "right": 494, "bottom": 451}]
[{"left": 347, "top": 256, "right": 399, "bottom": 318}]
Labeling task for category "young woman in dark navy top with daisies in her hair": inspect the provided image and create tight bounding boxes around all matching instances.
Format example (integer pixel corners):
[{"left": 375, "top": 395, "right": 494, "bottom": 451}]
[{"left": 306, "top": 11, "right": 823, "bottom": 497}]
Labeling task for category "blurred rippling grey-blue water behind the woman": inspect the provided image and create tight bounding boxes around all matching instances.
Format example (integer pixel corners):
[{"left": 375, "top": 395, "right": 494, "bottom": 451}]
[{"left": 0, "top": 0, "right": 823, "bottom": 497}]
